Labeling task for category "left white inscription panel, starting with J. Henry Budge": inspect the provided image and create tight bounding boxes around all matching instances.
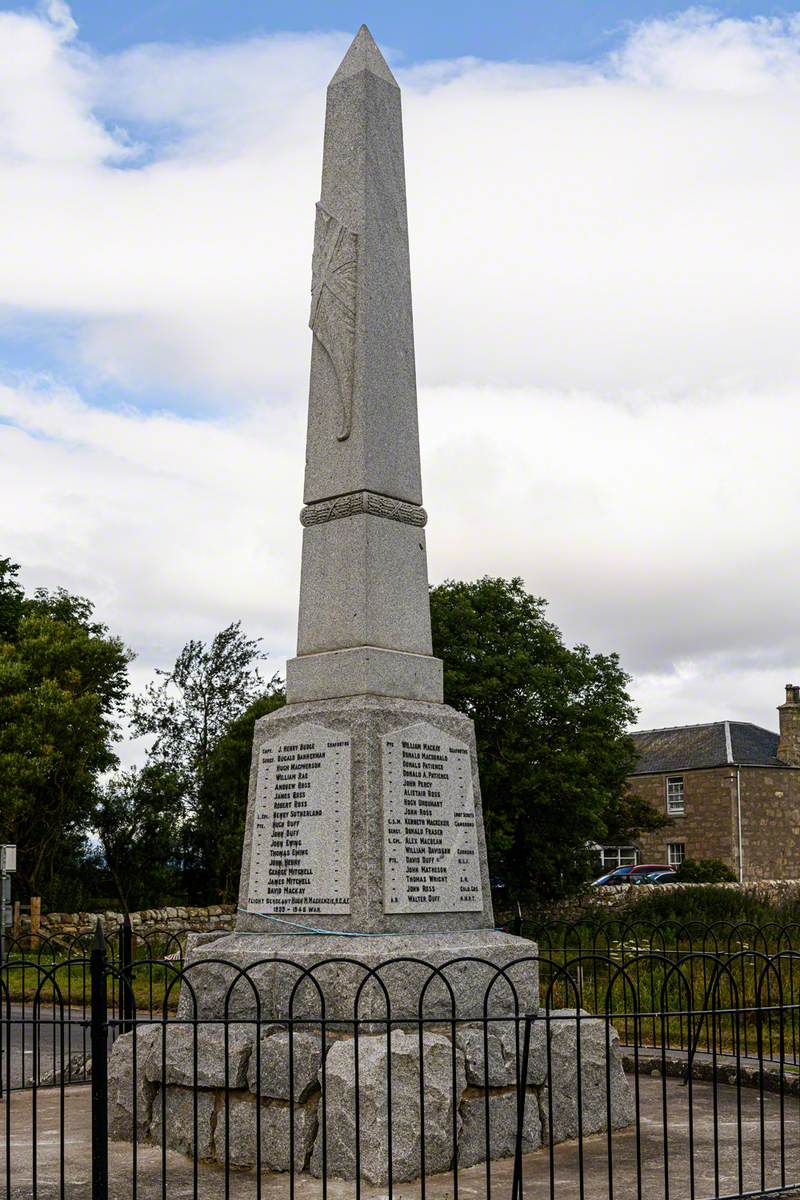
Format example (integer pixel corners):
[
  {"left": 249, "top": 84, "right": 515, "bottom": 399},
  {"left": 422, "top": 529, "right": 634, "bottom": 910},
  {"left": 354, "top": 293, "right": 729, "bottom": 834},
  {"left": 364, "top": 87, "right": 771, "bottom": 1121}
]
[{"left": 247, "top": 725, "right": 350, "bottom": 914}]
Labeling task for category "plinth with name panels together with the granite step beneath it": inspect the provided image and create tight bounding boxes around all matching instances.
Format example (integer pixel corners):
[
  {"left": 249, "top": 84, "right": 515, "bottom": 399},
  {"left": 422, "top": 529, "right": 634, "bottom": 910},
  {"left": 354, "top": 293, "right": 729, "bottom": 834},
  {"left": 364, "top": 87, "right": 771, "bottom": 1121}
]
[{"left": 181, "top": 696, "right": 539, "bottom": 1021}]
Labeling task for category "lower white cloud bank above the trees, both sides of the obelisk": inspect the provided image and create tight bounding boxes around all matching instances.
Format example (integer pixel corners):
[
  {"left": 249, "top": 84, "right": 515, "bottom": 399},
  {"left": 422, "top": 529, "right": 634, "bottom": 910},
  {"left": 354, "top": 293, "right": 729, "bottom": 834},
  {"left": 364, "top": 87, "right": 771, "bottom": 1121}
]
[{"left": 0, "top": 372, "right": 800, "bottom": 724}]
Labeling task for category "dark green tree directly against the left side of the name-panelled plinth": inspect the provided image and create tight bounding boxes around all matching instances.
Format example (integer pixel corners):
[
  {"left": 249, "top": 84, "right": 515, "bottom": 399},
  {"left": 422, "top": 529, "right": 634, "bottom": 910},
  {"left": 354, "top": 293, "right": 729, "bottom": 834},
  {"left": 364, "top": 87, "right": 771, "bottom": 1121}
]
[{"left": 186, "top": 683, "right": 285, "bottom": 904}]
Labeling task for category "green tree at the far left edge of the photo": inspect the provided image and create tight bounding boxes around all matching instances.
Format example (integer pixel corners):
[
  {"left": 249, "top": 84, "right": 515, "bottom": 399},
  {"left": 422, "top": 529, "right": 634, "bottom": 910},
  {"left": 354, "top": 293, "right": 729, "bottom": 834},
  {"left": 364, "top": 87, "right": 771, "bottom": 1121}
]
[{"left": 0, "top": 559, "right": 132, "bottom": 904}]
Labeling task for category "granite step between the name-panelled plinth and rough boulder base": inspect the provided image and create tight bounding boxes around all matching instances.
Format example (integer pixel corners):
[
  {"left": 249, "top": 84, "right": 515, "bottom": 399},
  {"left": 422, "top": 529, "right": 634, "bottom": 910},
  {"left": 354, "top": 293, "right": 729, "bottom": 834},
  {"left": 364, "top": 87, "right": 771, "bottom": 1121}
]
[{"left": 179, "top": 929, "right": 539, "bottom": 1022}]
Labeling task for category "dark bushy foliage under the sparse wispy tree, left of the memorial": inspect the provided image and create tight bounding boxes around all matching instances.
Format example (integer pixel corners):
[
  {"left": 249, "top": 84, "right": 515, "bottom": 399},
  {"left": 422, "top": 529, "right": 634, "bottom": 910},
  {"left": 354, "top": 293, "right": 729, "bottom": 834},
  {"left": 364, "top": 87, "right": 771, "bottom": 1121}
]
[{"left": 92, "top": 766, "right": 184, "bottom": 912}]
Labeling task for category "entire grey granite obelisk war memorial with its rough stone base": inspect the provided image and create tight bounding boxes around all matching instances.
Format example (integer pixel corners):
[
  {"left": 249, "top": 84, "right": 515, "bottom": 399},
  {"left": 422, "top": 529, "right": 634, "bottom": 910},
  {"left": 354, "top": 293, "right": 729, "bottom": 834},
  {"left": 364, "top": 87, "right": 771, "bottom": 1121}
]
[{"left": 109, "top": 26, "right": 632, "bottom": 1183}]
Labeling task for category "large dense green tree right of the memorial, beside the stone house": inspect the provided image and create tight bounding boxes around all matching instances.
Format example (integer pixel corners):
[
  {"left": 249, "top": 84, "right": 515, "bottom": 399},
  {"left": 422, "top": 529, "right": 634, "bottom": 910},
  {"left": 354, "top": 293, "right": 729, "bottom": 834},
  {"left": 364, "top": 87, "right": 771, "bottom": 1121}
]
[{"left": 431, "top": 577, "right": 663, "bottom": 901}]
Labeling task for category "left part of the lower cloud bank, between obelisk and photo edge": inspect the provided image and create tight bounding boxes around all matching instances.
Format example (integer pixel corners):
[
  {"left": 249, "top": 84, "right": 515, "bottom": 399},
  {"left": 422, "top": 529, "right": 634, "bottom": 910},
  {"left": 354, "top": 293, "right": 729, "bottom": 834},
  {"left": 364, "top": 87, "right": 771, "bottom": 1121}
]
[{"left": 0, "top": 388, "right": 302, "bottom": 666}]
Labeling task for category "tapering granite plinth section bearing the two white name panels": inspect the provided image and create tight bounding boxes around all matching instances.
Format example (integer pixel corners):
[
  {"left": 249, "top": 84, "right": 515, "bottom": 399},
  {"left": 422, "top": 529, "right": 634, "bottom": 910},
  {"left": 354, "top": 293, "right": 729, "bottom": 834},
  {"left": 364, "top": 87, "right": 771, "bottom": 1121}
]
[{"left": 237, "top": 696, "right": 493, "bottom": 936}]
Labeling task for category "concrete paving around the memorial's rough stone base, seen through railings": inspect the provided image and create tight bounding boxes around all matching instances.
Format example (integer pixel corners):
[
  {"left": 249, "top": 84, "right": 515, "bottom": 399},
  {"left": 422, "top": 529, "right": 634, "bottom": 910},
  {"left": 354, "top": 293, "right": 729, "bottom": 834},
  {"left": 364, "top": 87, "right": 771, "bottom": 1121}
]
[{"left": 0, "top": 1076, "right": 800, "bottom": 1200}]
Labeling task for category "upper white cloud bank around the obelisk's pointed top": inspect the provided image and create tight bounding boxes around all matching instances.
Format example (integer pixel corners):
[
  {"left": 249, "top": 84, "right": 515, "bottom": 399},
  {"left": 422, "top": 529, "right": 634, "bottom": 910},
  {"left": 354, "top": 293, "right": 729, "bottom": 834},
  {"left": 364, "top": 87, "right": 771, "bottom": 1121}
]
[{"left": 0, "top": 7, "right": 800, "bottom": 403}]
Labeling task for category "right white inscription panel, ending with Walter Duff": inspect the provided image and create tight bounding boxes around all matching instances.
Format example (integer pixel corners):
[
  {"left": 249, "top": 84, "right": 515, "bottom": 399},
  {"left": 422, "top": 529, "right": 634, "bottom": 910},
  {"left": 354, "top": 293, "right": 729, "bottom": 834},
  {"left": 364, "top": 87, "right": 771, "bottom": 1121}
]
[{"left": 381, "top": 722, "right": 483, "bottom": 912}]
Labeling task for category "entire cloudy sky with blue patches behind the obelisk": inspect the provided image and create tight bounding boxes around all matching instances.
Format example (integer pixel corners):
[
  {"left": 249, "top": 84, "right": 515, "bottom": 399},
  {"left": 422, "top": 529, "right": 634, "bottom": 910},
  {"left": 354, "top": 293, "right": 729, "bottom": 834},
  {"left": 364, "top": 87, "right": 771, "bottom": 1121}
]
[{"left": 0, "top": 0, "right": 800, "bottom": 748}]
